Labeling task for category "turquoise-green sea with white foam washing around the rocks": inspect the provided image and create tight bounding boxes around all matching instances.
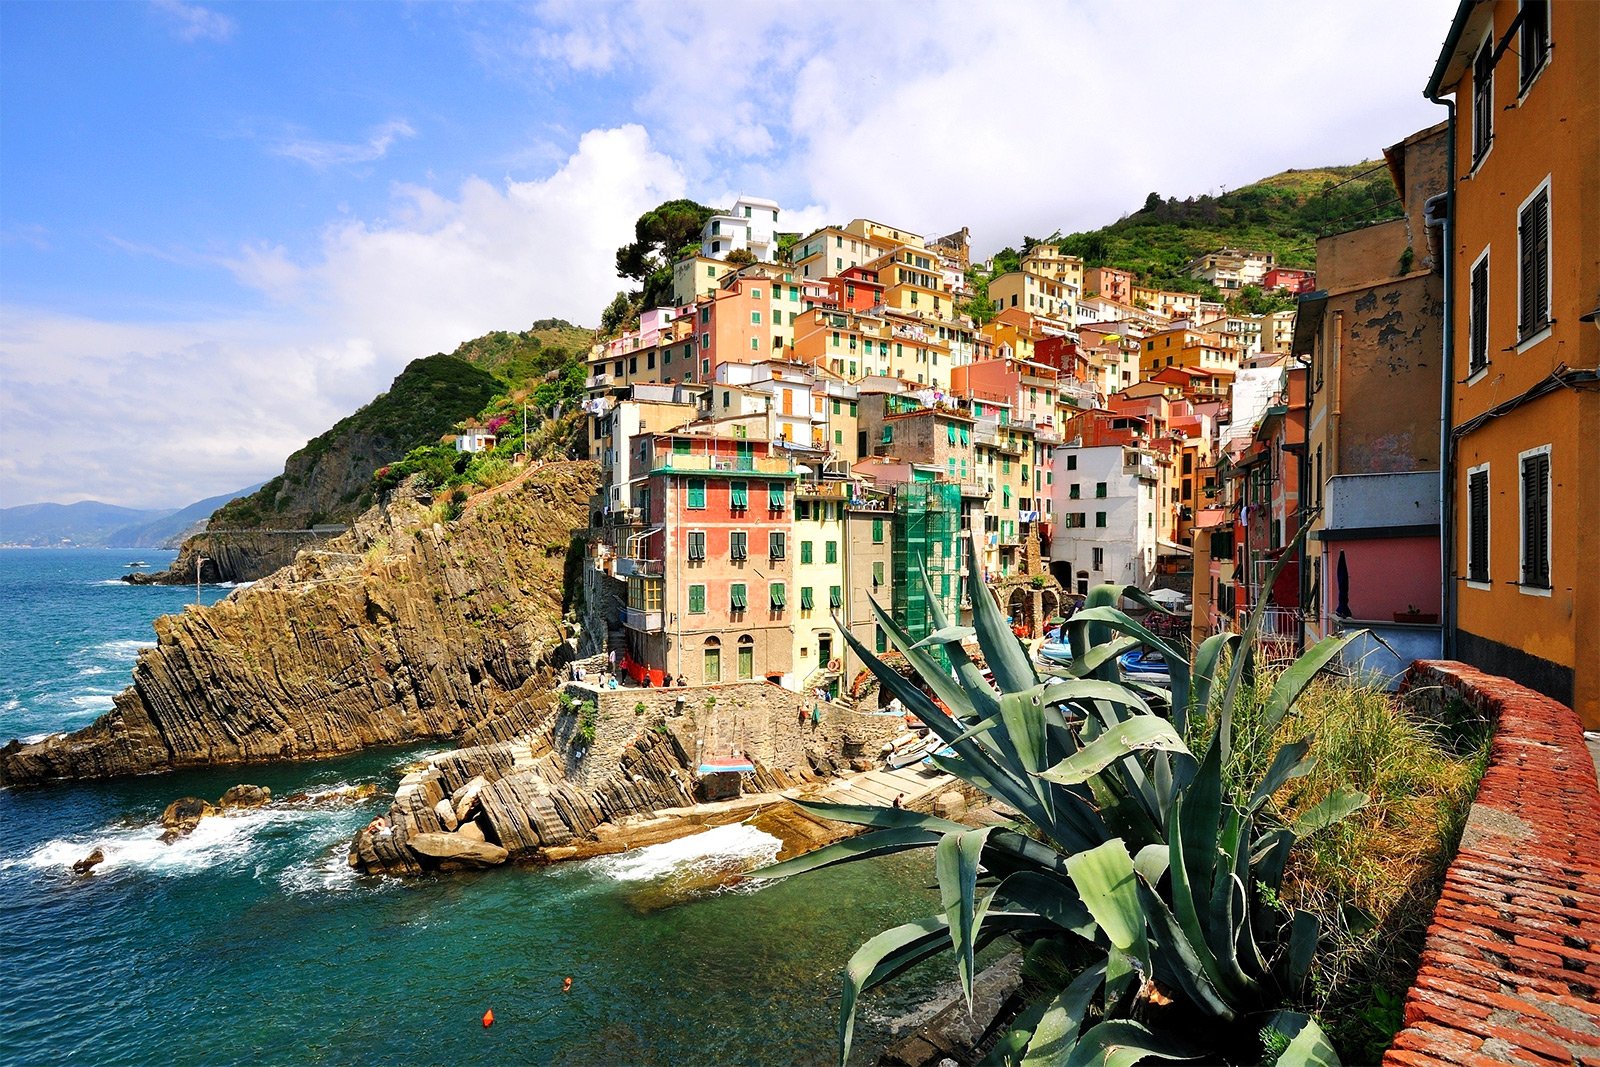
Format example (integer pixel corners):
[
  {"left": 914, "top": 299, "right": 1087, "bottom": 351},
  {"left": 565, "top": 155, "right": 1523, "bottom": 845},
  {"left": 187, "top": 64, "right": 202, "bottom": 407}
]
[{"left": 0, "top": 549, "right": 949, "bottom": 1064}]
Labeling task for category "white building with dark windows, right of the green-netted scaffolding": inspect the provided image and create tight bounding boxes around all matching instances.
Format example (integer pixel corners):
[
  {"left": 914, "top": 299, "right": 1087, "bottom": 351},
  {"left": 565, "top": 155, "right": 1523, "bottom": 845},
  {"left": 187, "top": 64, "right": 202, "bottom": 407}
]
[{"left": 1050, "top": 445, "right": 1160, "bottom": 593}]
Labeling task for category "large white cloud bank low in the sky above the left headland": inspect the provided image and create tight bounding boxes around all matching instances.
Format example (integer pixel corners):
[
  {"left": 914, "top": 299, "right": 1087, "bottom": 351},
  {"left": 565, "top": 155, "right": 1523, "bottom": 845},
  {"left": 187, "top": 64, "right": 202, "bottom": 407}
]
[{"left": 0, "top": 126, "right": 683, "bottom": 507}]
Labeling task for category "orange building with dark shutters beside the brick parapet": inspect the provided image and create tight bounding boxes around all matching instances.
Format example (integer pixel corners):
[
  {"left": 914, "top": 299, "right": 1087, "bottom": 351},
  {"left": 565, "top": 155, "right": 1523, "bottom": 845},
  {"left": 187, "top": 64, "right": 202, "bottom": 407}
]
[{"left": 1427, "top": 0, "right": 1600, "bottom": 729}]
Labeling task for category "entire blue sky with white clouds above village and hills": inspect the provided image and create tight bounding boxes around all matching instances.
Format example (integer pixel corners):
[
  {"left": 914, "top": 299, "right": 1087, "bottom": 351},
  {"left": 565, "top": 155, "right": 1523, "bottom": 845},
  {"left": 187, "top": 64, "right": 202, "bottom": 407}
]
[{"left": 0, "top": 0, "right": 1454, "bottom": 507}]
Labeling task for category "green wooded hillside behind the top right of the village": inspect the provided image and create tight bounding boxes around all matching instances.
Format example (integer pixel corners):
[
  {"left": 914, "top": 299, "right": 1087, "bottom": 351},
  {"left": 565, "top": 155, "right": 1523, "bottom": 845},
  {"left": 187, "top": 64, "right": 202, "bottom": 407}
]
[{"left": 1048, "top": 160, "right": 1400, "bottom": 291}]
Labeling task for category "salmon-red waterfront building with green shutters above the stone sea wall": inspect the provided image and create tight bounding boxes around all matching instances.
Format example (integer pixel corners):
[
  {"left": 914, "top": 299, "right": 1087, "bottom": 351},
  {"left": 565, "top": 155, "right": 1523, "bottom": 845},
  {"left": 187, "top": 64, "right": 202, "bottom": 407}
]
[{"left": 618, "top": 432, "right": 797, "bottom": 685}]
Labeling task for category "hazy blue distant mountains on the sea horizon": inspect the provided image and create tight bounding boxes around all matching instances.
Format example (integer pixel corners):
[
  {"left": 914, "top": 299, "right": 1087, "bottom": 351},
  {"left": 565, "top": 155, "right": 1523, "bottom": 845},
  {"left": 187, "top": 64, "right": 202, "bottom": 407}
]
[{"left": 0, "top": 483, "right": 261, "bottom": 549}]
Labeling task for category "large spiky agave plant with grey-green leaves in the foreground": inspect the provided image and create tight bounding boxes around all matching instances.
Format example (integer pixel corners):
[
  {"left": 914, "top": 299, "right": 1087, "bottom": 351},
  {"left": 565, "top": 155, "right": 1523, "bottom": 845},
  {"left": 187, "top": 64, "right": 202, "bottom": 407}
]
[{"left": 757, "top": 534, "right": 1366, "bottom": 1065}]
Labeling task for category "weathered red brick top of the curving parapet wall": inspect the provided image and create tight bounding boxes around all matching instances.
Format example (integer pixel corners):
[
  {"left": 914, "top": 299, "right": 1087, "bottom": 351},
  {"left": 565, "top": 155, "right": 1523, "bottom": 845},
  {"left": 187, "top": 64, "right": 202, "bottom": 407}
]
[{"left": 1384, "top": 661, "right": 1600, "bottom": 1067}]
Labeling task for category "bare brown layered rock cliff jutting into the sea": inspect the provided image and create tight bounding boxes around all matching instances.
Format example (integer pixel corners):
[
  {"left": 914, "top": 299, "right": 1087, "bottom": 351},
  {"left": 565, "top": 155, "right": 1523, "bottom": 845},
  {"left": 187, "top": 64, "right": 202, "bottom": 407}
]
[{"left": 0, "top": 462, "right": 595, "bottom": 784}]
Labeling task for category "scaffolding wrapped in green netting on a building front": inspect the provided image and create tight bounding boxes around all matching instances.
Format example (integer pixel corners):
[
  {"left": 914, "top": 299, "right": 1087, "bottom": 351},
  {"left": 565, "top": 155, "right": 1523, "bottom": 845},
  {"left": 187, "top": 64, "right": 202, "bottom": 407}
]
[{"left": 891, "top": 482, "right": 962, "bottom": 640}]
